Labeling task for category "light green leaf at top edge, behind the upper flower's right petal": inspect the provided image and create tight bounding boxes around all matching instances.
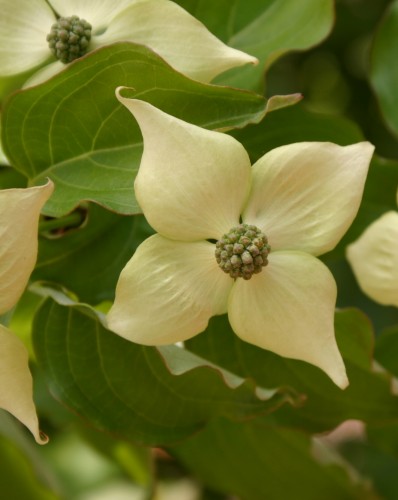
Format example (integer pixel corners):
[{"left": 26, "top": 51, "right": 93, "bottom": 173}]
[{"left": 178, "top": 0, "right": 334, "bottom": 89}]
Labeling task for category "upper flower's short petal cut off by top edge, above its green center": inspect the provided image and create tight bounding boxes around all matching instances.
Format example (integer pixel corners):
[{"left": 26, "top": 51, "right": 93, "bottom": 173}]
[{"left": 49, "top": 0, "right": 135, "bottom": 32}]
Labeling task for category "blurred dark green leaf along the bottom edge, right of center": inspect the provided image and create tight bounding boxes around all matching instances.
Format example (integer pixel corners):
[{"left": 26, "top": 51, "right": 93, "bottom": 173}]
[{"left": 170, "top": 419, "right": 374, "bottom": 500}]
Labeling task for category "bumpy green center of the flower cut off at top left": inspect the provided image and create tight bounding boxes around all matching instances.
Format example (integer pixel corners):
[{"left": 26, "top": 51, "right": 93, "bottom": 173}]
[{"left": 47, "top": 16, "right": 91, "bottom": 64}]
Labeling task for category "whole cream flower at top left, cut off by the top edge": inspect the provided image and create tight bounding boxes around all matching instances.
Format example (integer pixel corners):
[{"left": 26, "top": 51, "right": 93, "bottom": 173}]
[{"left": 0, "top": 0, "right": 258, "bottom": 84}]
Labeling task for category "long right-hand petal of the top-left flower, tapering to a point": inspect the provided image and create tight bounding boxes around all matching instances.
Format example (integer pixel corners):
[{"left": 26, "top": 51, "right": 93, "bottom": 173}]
[{"left": 93, "top": 0, "right": 258, "bottom": 82}]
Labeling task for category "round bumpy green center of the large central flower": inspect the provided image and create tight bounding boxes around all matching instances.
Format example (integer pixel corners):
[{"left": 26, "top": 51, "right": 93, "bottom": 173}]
[{"left": 215, "top": 224, "right": 271, "bottom": 280}]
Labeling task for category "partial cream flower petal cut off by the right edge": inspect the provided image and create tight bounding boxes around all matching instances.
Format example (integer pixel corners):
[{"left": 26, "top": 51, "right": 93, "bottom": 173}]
[{"left": 346, "top": 187, "right": 398, "bottom": 307}]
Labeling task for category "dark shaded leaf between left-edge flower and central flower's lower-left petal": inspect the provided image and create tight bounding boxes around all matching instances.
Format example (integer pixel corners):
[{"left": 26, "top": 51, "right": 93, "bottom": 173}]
[{"left": 32, "top": 204, "right": 152, "bottom": 304}]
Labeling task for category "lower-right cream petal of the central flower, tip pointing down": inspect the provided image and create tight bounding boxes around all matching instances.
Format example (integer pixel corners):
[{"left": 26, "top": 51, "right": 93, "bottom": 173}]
[{"left": 228, "top": 251, "right": 348, "bottom": 389}]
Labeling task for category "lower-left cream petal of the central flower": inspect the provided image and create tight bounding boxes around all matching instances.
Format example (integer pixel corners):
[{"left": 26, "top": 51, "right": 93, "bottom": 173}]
[{"left": 108, "top": 234, "right": 233, "bottom": 345}]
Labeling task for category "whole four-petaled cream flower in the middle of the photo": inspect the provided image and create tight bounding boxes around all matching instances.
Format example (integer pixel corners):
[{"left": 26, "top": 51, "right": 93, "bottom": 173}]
[{"left": 108, "top": 94, "right": 373, "bottom": 388}]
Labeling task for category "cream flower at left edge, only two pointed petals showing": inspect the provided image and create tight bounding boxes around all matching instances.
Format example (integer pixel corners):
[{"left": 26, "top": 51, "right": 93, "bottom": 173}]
[{"left": 0, "top": 182, "right": 53, "bottom": 444}]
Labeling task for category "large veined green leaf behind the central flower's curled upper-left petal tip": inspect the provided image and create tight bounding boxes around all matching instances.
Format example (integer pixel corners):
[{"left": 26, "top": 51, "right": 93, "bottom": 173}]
[{"left": 2, "top": 43, "right": 266, "bottom": 217}]
